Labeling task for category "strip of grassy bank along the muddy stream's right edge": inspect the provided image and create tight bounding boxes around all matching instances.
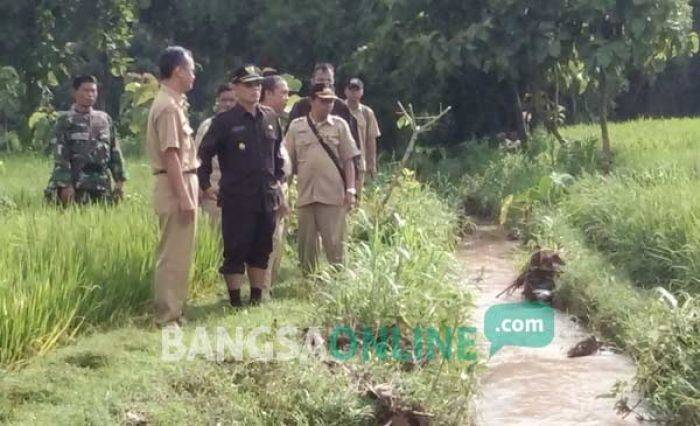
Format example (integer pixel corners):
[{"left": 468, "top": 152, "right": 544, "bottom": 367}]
[{"left": 530, "top": 209, "right": 700, "bottom": 425}]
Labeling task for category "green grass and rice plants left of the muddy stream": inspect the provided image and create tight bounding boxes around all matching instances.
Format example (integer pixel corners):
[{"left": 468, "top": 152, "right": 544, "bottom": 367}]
[{"left": 0, "top": 157, "right": 475, "bottom": 425}]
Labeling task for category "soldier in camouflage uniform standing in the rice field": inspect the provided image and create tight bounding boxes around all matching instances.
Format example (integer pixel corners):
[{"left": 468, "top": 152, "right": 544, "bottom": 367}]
[{"left": 44, "top": 75, "right": 126, "bottom": 205}]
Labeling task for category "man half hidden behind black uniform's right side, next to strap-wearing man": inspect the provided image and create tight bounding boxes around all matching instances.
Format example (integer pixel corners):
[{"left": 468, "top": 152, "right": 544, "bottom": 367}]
[{"left": 260, "top": 71, "right": 292, "bottom": 287}]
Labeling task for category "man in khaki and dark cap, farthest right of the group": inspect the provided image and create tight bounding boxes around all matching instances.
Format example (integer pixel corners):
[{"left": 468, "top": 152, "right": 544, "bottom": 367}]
[{"left": 345, "top": 78, "right": 382, "bottom": 181}]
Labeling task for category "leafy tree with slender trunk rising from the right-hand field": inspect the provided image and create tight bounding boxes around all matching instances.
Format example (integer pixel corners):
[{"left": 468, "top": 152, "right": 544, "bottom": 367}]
[{"left": 568, "top": 0, "right": 698, "bottom": 173}]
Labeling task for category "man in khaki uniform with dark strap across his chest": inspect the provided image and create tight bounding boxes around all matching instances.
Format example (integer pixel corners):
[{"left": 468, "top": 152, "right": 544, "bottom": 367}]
[{"left": 285, "top": 84, "right": 360, "bottom": 273}]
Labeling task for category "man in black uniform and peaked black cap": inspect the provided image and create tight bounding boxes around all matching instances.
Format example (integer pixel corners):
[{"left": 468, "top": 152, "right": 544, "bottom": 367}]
[{"left": 197, "top": 65, "right": 288, "bottom": 306}]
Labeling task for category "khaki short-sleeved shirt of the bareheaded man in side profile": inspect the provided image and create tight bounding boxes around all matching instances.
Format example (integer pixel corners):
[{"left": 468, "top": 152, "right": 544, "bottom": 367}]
[{"left": 146, "top": 85, "right": 199, "bottom": 172}]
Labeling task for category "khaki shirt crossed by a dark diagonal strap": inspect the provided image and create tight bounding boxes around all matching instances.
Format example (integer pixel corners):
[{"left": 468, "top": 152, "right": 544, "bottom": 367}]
[{"left": 284, "top": 115, "right": 360, "bottom": 207}]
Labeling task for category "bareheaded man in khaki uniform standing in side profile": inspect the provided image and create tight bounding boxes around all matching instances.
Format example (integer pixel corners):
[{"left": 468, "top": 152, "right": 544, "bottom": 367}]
[{"left": 146, "top": 46, "right": 199, "bottom": 325}]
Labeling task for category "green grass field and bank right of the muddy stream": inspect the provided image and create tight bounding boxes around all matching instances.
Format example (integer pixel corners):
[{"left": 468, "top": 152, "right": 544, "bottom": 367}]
[{"left": 432, "top": 119, "right": 700, "bottom": 424}]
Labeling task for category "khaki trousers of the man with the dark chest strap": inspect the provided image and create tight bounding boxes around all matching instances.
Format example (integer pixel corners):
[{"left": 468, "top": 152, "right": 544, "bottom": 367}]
[{"left": 297, "top": 203, "right": 347, "bottom": 273}]
